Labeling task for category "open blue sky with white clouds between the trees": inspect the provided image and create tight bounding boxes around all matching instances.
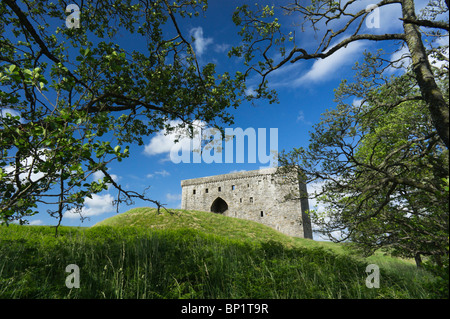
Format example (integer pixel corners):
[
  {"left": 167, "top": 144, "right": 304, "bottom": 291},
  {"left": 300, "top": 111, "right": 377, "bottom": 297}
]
[{"left": 7, "top": 0, "right": 442, "bottom": 230}]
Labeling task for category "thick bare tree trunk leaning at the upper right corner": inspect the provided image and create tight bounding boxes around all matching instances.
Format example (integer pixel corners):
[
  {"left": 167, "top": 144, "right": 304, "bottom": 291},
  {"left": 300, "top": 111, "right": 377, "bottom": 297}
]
[{"left": 402, "top": 0, "right": 449, "bottom": 149}]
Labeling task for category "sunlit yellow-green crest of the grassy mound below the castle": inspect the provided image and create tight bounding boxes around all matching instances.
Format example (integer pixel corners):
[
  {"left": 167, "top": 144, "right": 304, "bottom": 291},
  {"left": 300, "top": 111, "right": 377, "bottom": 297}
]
[{"left": 93, "top": 207, "right": 414, "bottom": 269}]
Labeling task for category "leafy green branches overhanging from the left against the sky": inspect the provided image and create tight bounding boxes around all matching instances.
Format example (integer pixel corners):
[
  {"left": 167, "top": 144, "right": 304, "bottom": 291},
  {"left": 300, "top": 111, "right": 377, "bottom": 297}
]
[{"left": 0, "top": 0, "right": 245, "bottom": 226}]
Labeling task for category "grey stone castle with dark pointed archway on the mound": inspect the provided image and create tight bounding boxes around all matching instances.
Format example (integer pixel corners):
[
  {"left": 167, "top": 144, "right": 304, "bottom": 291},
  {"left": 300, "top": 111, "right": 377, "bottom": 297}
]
[{"left": 181, "top": 168, "right": 312, "bottom": 239}]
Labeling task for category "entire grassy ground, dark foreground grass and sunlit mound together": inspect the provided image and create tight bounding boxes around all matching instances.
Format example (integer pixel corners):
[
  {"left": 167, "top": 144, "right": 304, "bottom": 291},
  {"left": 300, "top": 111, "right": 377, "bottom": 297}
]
[{"left": 0, "top": 208, "right": 442, "bottom": 298}]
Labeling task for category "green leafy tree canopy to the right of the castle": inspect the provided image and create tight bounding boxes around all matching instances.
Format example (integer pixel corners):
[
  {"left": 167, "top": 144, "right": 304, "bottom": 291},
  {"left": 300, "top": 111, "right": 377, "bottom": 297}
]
[{"left": 280, "top": 53, "right": 449, "bottom": 264}]
